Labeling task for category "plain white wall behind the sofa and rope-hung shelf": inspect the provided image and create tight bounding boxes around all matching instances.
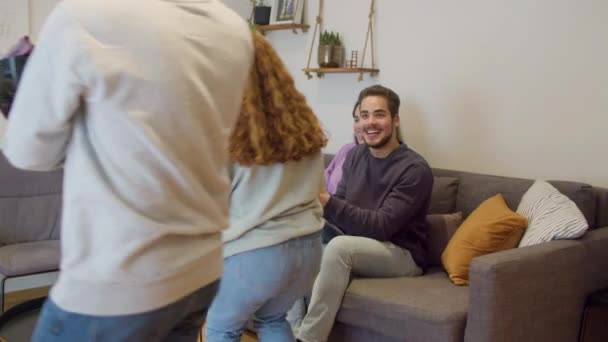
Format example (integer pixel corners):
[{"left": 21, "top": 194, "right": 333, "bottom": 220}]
[{"left": 225, "top": 0, "right": 608, "bottom": 186}]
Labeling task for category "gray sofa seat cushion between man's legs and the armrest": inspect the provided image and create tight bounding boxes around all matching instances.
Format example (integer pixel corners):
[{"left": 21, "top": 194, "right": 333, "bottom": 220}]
[{"left": 336, "top": 267, "right": 469, "bottom": 341}]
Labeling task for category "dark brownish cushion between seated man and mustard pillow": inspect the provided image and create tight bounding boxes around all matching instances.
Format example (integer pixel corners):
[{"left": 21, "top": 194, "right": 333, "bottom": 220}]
[{"left": 426, "top": 213, "right": 462, "bottom": 266}]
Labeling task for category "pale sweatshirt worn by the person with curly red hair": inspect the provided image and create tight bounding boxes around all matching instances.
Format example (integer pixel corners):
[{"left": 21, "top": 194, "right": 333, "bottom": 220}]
[{"left": 224, "top": 152, "right": 325, "bottom": 257}]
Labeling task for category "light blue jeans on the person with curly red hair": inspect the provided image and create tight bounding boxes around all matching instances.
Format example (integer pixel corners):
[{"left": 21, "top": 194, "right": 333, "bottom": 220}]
[{"left": 205, "top": 233, "right": 322, "bottom": 342}]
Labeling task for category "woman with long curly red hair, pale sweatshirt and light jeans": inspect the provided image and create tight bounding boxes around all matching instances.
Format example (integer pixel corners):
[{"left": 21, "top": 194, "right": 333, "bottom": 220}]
[{"left": 205, "top": 33, "right": 327, "bottom": 342}]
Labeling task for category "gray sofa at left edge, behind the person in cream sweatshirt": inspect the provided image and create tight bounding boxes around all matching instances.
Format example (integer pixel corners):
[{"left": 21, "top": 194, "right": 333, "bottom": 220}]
[{"left": 0, "top": 152, "right": 63, "bottom": 311}]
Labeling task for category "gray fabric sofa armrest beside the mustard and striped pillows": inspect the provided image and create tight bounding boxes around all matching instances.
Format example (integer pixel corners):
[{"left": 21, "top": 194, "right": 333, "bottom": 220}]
[{"left": 465, "top": 240, "right": 587, "bottom": 342}]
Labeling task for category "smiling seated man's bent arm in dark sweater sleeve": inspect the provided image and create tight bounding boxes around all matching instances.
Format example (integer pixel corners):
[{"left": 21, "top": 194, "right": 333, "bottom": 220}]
[{"left": 324, "top": 165, "right": 433, "bottom": 241}]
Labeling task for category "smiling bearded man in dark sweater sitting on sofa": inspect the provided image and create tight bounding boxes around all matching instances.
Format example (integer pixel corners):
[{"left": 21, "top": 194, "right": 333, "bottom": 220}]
[{"left": 296, "top": 85, "right": 433, "bottom": 342}]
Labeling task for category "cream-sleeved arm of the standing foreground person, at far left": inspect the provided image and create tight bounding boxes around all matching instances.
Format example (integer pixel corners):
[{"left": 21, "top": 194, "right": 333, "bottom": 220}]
[{"left": 3, "top": 4, "right": 86, "bottom": 171}]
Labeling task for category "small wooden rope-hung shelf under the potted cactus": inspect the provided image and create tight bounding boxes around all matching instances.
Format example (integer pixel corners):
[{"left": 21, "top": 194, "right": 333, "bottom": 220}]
[{"left": 303, "top": 0, "right": 380, "bottom": 81}]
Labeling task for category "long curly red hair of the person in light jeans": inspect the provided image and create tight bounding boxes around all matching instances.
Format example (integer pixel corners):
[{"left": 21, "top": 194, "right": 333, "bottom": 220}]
[{"left": 230, "top": 32, "right": 327, "bottom": 166}]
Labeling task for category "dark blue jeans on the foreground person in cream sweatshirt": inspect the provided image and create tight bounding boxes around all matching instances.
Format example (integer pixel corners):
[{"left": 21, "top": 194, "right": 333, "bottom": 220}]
[{"left": 32, "top": 281, "right": 219, "bottom": 342}]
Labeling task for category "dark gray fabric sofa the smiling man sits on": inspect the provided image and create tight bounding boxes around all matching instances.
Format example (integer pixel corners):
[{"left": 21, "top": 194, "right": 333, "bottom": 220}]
[{"left": 326, "top": 155, "right": 608, "bottom": 342}]
